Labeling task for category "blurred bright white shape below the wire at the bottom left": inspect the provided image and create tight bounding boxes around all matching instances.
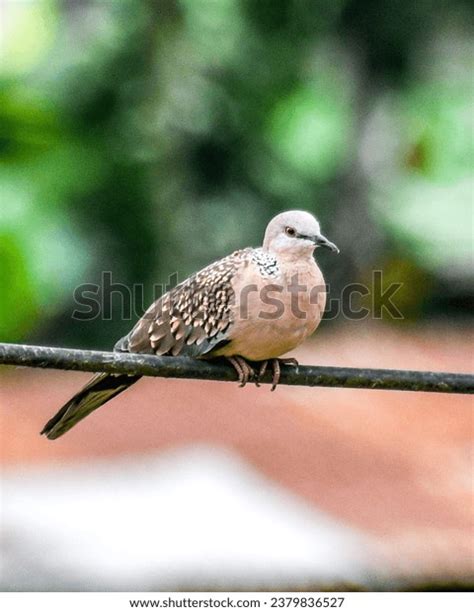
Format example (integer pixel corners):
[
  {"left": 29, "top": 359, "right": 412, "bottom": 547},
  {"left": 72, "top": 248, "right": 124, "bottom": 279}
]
[{"left": 0, "top": 446, "right": 380, "bottom": 590}]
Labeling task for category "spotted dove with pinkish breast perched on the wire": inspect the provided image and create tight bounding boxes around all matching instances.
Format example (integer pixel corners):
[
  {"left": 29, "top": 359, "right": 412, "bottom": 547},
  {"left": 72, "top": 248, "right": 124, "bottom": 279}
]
[{"left": 41, "top": 210, "right": 339, "bottom": 440}]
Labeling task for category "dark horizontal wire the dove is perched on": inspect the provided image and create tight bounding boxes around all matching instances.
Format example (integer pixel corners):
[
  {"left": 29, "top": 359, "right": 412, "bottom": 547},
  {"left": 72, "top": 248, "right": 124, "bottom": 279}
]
[{"left": 0, "top": 343, "right": 474, "bottom": 393}]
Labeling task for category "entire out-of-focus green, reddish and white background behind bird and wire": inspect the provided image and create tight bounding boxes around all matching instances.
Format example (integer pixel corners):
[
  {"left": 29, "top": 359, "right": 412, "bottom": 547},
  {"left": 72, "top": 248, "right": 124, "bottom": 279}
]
[{"left": 0, "top": 0, "right": 474, "bottom": 590}]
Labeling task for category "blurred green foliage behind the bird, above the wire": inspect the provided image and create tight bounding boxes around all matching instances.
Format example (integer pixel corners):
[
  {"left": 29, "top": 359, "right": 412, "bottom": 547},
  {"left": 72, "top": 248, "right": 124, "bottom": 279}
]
[{"left": 0, "top": 0, "right": 474, "bottom": 347}]
